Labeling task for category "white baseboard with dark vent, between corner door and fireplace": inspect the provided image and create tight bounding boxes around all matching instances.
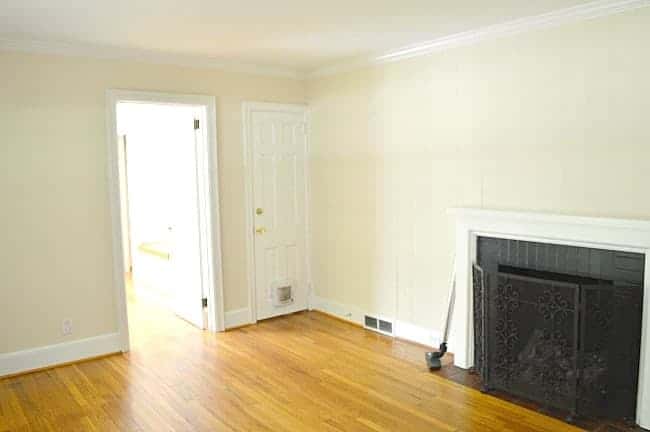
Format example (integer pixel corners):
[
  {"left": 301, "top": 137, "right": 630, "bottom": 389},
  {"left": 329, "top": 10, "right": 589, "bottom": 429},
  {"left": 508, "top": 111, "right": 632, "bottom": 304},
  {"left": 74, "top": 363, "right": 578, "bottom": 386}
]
[{"left": 311, "top": 296, "right": 441, "bottom": 348}]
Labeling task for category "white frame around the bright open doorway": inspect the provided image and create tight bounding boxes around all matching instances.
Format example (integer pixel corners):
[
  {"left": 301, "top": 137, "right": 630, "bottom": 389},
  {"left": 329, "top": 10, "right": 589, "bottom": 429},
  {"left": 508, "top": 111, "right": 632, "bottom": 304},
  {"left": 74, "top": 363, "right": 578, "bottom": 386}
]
[{"left": 106, "top": 89, "right": 224, "bottom": 352}]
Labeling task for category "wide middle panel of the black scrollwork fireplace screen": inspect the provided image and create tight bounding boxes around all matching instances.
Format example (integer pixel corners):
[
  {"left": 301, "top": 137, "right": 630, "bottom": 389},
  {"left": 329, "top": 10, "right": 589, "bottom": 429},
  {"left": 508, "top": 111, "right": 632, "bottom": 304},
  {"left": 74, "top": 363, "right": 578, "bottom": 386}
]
[{"left": 484, "top": 273, "right": 579, "bottom": 412}]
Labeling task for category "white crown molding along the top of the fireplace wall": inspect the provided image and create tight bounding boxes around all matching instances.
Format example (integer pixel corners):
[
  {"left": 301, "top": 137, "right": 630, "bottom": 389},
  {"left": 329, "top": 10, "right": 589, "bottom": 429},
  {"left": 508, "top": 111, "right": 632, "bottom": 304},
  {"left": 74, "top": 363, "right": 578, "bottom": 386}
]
[{"left": 307, "top": 0, "right": 650, "bottom": 78}]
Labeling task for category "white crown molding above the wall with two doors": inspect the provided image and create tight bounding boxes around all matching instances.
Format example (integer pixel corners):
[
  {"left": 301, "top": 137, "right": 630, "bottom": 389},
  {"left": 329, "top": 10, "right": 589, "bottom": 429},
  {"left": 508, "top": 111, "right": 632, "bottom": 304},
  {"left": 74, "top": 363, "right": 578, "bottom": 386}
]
[{"left": 0, "top": 38, "right": 305, "bottom": 80}]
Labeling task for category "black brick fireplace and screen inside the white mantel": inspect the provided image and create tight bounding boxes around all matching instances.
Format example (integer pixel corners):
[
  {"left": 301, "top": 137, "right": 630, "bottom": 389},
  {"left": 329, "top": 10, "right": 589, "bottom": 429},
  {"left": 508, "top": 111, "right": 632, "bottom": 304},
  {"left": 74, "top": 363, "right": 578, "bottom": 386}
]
[{"left": 473, "top": 237, "right": 644, "bottom": 419}]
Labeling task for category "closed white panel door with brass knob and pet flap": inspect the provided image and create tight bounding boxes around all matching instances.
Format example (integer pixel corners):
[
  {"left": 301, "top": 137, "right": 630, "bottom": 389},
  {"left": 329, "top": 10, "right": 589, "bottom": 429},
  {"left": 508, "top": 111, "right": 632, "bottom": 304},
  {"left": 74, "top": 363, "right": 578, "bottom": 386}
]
[{"left": 249, "top": 109, "right": 307, "bottom": 319}]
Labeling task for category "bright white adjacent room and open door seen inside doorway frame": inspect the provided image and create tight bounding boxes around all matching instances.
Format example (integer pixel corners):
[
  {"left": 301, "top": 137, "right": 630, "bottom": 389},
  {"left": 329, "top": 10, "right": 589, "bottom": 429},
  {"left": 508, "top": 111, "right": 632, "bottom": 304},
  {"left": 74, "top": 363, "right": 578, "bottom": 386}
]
[{"left": 116, "top": 101, "right": 218, "bottom": 344}]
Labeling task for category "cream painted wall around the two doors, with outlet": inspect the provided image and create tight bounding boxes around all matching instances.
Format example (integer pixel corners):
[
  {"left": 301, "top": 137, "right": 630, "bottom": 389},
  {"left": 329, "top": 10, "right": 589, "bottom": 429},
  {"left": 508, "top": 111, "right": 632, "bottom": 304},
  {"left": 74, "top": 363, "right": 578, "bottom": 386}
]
[{"left": 0, "top": 52, "right": 305, "bottom": 353}]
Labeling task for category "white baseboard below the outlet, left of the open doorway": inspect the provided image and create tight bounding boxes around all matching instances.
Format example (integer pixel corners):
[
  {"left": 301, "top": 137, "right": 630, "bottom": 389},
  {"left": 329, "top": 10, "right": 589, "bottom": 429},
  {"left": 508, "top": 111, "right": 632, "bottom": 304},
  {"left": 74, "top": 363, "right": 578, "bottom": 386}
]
[{"left": 0, "top": 333, "right": 122, "bottom": 376}]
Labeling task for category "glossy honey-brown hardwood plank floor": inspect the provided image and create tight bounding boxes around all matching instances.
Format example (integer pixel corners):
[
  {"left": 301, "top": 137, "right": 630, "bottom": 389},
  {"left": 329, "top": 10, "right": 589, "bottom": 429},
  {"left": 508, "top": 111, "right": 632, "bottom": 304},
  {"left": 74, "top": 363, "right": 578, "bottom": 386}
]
[{"left": 0, "top": 292, "right": 596, "bottom": 432}]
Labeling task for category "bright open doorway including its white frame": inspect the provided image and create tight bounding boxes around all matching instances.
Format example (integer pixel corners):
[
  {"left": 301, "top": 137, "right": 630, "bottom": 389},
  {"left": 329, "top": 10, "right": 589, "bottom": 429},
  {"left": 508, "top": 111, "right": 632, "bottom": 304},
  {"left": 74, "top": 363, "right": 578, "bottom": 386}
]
[{"left": 109, "top": 92, "right": 223, "bottom": 351}]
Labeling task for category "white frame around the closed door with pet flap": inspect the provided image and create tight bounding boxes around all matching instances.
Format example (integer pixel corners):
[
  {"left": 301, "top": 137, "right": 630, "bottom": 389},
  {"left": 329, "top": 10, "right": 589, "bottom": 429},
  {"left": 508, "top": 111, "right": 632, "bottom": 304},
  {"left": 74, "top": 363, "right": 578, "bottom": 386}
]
[{"left": 242, "top": 101, "right": 313, "bottom": 324}]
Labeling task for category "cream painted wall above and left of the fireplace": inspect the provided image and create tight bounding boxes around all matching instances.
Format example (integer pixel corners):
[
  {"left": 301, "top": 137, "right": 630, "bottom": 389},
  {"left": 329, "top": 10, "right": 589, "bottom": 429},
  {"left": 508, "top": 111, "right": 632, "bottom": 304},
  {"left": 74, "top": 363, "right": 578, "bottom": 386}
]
[{"left": 308, "top": 8, "right": 650, "bottom": 336}]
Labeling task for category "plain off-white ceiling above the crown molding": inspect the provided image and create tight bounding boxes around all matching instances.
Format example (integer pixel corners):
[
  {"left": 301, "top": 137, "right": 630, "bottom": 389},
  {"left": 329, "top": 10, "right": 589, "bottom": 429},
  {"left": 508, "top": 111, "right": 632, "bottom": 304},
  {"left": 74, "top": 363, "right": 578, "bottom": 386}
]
[{"left": 0, "top": 0, "right": 585, "bottom": 73}]
